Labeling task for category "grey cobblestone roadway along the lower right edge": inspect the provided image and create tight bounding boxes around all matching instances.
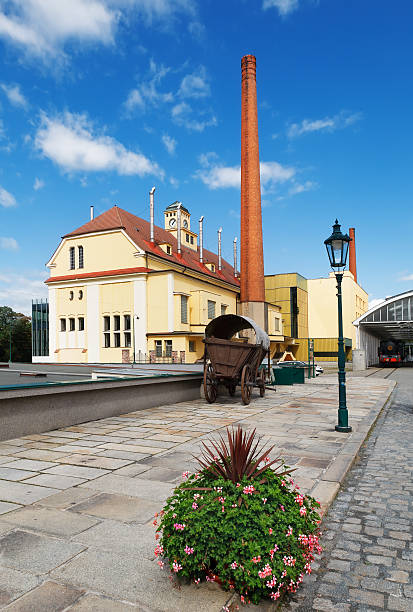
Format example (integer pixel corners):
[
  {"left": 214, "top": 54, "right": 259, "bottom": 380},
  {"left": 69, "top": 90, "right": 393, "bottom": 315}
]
[{"left": 282, "top": 369, "right": 413, "bottom": 612}]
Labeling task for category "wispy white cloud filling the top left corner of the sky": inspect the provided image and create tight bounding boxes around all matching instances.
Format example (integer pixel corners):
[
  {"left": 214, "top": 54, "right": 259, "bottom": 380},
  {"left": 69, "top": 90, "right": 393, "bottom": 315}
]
[{"left": 0, "top": 0, "right": 118, "bottom": 62}]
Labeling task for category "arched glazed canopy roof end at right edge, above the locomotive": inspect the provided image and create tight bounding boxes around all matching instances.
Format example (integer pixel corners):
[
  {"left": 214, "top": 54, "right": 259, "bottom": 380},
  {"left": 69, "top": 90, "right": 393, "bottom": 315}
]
[{"left": 354, "top": 291, "right": 413, "bottom": 340}]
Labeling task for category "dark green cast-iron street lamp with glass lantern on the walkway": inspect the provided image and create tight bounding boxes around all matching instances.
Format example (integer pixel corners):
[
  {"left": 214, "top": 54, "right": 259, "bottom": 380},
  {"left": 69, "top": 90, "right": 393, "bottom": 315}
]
[{"left": 324, "top": 219, "right": 351, "bottom": 433}]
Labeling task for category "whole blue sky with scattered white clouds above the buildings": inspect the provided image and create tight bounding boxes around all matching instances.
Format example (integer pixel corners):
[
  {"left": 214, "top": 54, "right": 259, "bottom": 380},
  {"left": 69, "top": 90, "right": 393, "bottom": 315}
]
[{"left": 0, "top": 0, "right": 413, "bottom": 312}]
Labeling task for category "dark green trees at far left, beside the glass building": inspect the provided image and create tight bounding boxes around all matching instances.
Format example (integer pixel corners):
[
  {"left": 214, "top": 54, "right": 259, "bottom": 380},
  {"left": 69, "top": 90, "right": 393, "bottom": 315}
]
[{"left": 0, "top": 306, "right": 32, "bottom": 362}]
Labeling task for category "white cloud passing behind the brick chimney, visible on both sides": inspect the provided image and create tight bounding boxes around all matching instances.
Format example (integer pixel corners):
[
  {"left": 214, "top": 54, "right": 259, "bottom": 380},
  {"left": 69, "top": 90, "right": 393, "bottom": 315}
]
[{"left": 195, "top": 154, "right": 296, "bottom": 189}]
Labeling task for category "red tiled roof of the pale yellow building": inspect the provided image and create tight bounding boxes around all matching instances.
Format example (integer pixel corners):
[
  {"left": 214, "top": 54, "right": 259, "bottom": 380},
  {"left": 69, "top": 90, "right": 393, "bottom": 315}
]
[{"left": 62, "top": 206, "right": 239, "bottom": 287}]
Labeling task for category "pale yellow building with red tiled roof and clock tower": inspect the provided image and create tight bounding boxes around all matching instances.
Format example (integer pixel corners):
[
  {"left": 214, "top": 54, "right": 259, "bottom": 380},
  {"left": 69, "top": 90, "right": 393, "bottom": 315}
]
[{"left": 42, "top": 202, "right": 283, "bottom": 363}]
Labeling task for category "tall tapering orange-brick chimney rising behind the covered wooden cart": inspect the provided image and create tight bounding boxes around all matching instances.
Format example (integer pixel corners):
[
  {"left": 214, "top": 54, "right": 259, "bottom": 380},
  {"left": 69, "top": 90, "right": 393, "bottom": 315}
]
[{"left": 240, "top": 55, "right": 267, "bottom": 329}]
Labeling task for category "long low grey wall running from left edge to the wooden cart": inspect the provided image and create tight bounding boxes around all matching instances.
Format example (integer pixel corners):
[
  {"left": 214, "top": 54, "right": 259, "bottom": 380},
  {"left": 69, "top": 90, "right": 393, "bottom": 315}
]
[{"left": 0, "top": 374, "right": 202, "bottom": 441}]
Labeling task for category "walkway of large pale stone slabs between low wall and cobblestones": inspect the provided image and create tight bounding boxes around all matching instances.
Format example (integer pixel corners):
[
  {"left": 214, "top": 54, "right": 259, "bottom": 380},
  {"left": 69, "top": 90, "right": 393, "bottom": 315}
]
[{"left": 0, "top": 375, "right": 394, "bottom": 612}]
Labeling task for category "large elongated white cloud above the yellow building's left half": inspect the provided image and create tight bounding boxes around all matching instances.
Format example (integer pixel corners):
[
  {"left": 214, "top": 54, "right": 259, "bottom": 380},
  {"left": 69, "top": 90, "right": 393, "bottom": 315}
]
[{"left": 34, "top": 112, "right": 163, "bottom": 176}]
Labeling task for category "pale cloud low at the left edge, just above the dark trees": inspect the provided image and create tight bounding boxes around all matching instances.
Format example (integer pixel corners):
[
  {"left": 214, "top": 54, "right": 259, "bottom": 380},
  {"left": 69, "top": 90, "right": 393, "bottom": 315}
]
[{"left": 0, "top": 269, "right": 48, "bottom": 315}]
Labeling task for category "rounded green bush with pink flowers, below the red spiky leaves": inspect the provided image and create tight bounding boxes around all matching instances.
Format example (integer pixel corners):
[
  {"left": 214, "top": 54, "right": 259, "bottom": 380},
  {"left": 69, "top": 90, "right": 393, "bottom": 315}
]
[{"left": 154, "top": 466, "right": 321, "bottom": 604}]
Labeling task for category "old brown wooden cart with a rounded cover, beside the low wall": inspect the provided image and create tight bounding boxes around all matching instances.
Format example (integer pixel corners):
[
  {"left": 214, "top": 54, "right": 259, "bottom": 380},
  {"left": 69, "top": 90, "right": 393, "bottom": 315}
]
[{"left": 204, "top": 315, "right": 270, "bottom": 404}]
